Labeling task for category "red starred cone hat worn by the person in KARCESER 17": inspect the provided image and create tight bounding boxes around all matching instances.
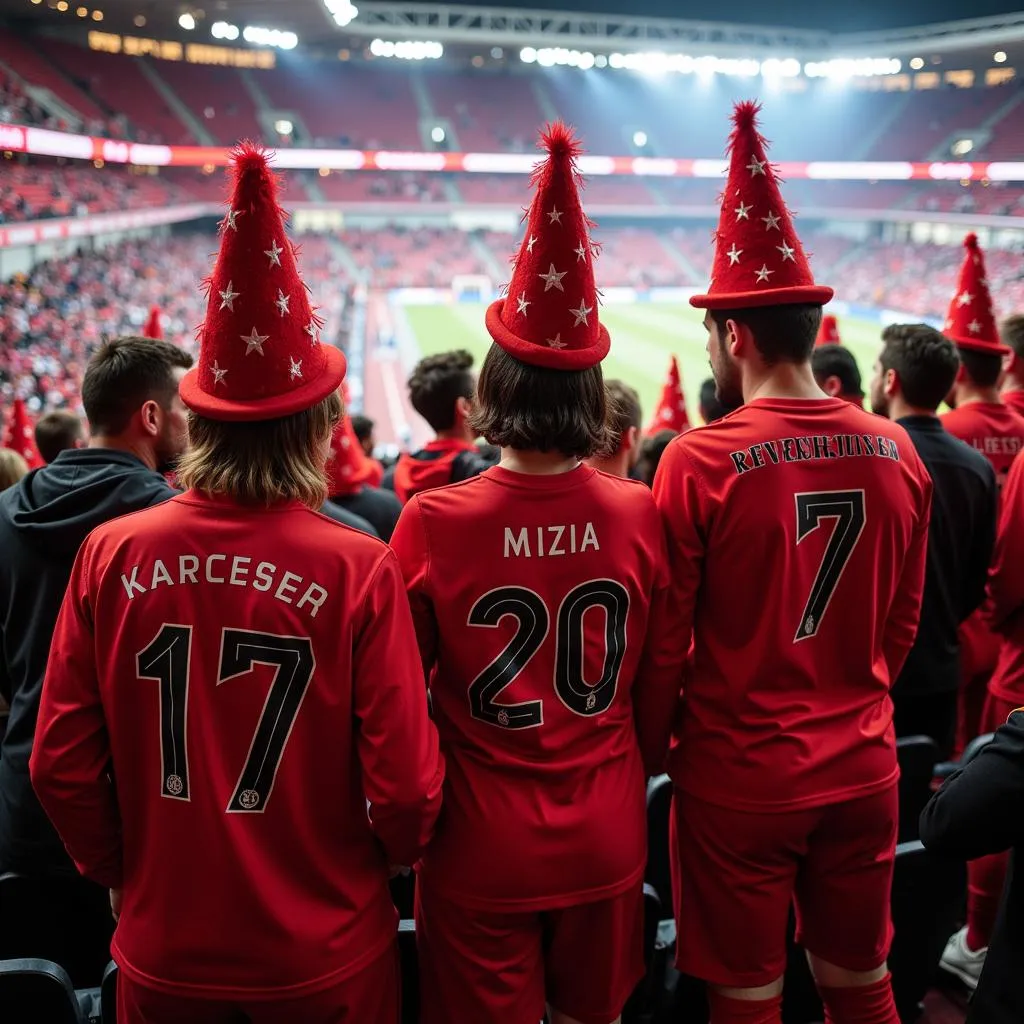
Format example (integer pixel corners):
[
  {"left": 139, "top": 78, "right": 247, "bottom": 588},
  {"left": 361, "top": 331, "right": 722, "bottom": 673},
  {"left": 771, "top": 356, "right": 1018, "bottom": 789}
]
[{"left": 181, "top": 142, "right": 345, "bottom": 420}]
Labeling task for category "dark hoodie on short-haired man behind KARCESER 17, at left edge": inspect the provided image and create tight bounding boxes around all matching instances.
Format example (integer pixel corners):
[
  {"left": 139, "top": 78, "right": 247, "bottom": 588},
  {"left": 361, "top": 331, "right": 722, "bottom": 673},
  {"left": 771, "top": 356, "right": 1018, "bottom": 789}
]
[{"left": 0, "top": 449, "right": 177, "bottom": 876}]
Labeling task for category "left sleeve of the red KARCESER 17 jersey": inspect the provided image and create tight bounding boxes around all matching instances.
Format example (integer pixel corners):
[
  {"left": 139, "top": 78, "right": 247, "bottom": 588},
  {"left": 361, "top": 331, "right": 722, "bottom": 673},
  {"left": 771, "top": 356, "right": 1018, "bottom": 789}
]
[{"left": 29, "top": 542, "right": 122, "bottom": 889}]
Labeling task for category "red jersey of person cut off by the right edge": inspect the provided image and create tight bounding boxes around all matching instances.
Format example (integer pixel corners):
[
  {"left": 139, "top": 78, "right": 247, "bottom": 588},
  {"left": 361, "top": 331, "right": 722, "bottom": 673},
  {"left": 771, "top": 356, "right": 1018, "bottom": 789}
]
[{"left": 982, "top": 459, "right": 1024, "bottom": 705}]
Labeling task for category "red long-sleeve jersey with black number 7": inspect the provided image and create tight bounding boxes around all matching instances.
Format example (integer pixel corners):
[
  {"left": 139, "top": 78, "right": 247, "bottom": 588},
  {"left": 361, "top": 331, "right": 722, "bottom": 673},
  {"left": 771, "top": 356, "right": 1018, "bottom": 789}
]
[{"left": 654, "top": 398, "right": 932, "bottom": 811}]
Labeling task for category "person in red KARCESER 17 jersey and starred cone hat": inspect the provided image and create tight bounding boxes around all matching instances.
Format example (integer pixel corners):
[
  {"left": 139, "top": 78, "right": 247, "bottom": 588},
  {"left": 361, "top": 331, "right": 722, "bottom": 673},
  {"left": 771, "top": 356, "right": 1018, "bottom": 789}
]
[{"left": 31, "top": 143, "right": 443, "bottom": 1024}]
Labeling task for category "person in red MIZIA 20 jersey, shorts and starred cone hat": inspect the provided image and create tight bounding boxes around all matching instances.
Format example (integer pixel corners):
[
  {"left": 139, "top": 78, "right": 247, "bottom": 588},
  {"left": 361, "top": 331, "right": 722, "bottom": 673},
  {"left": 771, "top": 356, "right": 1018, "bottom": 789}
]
[{"left": 391, "top": 125, "right": 688, "bottom": 1024}]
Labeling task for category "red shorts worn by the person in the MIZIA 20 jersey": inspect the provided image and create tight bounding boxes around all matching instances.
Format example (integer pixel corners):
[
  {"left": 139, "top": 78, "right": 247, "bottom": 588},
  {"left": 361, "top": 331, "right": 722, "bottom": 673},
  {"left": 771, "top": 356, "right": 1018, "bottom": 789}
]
[{"left": 416, "top": 882, "right": 644, "bottom": 1024}]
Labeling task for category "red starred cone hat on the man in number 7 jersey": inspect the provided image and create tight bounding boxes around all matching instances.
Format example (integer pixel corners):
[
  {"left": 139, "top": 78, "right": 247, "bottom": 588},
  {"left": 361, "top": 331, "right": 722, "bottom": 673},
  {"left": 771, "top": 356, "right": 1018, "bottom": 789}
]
[{"left": 690, "top": 100, "right": 833, "bottom": 309}]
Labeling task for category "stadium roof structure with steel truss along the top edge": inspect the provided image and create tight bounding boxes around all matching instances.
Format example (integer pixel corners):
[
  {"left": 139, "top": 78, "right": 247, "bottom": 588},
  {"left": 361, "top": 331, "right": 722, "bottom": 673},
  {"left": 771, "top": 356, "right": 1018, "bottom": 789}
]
[{"left": 6, "top": 0, "right": 1024, "bottom": 58}]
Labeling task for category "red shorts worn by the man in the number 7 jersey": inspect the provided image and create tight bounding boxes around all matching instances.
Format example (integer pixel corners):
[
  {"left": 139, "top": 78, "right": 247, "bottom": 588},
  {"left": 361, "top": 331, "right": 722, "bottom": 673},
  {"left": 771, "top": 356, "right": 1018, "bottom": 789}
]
[{"left": 670, "top": 786, "right": 899, "bottom": 988}]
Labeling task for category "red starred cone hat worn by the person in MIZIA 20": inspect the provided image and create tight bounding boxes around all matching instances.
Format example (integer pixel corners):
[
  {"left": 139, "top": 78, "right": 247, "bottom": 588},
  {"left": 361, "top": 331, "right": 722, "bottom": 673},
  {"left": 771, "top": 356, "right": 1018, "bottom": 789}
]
[{"left": 486, "top": 123, "right": 611, "bottom": 370}]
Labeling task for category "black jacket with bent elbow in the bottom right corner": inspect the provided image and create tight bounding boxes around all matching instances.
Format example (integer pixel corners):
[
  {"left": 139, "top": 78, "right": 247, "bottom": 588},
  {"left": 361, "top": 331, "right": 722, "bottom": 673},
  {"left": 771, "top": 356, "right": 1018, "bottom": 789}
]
[{"left": 921, "top": 711, "right": 1024, "bottom": 1024}]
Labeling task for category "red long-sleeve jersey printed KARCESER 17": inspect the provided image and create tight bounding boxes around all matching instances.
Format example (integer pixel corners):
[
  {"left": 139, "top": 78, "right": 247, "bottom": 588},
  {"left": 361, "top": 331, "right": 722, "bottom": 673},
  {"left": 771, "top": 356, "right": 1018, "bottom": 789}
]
[{"left": 31, "top": 492, "right": 443, "bottom": 997}]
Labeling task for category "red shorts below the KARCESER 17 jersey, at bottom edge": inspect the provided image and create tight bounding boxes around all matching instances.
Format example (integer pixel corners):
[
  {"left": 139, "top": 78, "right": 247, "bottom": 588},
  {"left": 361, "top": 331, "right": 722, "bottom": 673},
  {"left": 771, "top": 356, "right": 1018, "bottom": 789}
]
[{"left": 118, "top": 944, "right": 401, "bottom": 1024}]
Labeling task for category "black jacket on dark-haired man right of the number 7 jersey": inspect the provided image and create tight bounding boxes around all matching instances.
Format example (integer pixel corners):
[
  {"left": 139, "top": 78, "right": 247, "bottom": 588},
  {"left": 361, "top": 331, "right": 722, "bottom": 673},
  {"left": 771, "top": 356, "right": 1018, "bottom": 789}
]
[{"left": 893, "top": 416, "right": 998, "bottom": 700}]
